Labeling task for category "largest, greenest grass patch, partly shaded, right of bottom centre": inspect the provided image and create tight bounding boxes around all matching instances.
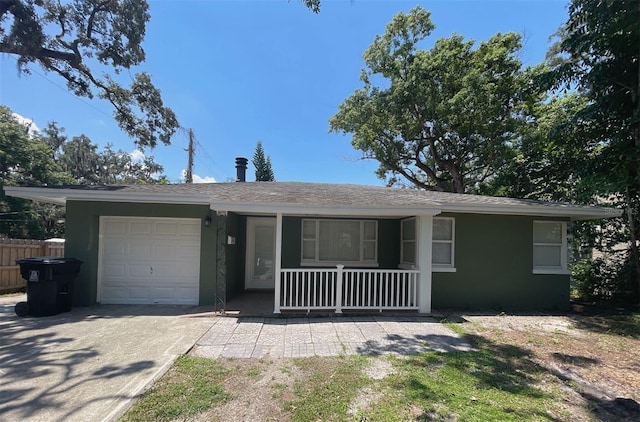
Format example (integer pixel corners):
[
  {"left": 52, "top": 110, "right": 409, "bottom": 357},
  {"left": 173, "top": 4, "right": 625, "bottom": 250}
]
[{"left": 362, "top": 337, "right": 560, "bottom": 421}]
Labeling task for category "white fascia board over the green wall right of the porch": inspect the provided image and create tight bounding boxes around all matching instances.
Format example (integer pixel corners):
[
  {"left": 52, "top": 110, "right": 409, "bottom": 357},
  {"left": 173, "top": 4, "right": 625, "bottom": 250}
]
[{"left": 442, "top": 204, "right": 623, "bottom": 220}]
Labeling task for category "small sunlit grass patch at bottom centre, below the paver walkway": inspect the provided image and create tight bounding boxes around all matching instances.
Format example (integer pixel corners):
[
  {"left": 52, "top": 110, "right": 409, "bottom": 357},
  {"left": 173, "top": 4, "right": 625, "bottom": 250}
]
[{"left": 285, "top": 356, "right": 369, "bottom": 422}]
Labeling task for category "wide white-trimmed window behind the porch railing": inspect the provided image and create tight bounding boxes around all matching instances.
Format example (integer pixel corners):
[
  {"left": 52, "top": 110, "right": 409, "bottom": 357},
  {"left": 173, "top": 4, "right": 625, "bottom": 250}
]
[{"left": 302, "top": 219, "right": 378, "bottom": 266}]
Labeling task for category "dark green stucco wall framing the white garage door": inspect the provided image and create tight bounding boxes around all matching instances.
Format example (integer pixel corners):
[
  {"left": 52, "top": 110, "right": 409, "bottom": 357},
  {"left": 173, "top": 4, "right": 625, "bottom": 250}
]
[{"left": 65, "top": 201, "right": 218, "bottom": 306}]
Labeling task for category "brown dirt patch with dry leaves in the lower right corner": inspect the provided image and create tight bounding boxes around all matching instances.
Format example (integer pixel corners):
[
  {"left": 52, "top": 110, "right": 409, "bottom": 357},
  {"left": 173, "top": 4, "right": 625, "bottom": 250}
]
[{"left": 463, "top": 315, "right": 640, "bottom": 421}]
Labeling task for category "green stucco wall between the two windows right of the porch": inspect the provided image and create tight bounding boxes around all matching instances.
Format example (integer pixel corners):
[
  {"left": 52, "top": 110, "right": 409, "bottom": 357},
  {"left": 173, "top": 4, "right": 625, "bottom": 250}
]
[{"left": 432, "top": 214, "right": 569, "bottom": 310}]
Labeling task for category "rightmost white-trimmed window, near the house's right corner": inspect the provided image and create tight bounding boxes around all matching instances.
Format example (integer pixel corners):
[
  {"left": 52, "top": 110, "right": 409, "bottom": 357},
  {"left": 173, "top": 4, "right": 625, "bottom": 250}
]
[{"left": 533, "top": 221, "right": 568, "bottom": 274}]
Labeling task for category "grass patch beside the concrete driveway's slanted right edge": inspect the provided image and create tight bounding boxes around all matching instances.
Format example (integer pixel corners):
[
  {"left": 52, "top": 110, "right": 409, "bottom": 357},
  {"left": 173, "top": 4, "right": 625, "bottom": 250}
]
[{"left": 120, "top": 356, "right": 231, "bottom": 422}]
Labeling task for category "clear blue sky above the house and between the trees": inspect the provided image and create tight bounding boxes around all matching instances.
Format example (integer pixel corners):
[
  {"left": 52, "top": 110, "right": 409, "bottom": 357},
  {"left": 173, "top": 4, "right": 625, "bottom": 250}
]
[{"left": 0, "top": 0, "right": 567, "bottom": 185}]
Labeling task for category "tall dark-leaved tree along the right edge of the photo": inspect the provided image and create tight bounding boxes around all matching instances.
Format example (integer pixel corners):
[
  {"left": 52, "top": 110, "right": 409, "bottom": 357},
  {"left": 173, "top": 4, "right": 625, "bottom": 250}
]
[{"left": 550, "top": 0, "right": 640, "bottom": 304}]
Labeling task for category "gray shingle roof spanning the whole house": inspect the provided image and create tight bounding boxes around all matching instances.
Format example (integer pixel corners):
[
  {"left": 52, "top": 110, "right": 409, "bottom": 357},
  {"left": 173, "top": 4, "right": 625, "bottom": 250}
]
[{"left": 11, "top": 182, "right": 620, "bottom": 218}]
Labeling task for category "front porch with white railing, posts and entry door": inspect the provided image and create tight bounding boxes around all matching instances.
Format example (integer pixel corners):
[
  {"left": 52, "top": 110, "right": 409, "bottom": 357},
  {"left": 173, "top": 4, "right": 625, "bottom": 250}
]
[{"left": 220, "top": 213, "right": 433, "bottom": 315}]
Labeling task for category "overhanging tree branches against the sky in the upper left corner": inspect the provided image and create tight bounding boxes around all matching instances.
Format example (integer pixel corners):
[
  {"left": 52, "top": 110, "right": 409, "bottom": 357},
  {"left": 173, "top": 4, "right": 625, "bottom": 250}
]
[{"left": 0, "top": 0, "right": 179, "bottom": 148}]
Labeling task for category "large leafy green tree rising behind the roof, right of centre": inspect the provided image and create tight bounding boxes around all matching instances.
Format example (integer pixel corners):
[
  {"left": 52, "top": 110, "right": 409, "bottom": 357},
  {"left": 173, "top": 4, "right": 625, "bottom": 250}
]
[{"left": 330, "top": 7, "right": 528, "bottom": 193}]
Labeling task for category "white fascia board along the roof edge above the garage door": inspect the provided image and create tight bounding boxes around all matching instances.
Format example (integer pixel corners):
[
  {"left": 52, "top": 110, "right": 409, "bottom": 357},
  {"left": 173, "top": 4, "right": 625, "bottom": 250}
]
[{"left": 4, "top": 186, "right": 209, "bottom": 205}]
